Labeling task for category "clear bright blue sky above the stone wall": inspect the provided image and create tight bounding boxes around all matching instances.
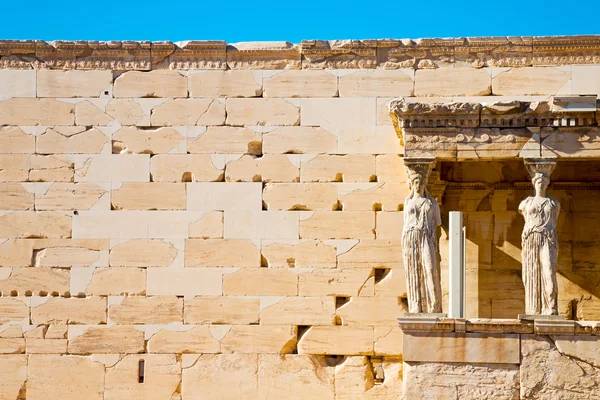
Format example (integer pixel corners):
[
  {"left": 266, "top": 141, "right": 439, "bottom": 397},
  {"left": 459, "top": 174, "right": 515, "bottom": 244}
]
[{"left": 0, "top": 0, "right": 600, "bottom": 43}]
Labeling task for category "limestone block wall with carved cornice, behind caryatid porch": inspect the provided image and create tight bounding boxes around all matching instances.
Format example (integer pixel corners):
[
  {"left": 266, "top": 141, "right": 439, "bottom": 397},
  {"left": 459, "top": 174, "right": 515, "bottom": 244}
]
[{"left": 0, "top": 37, "right": 600, "bottom": 400}]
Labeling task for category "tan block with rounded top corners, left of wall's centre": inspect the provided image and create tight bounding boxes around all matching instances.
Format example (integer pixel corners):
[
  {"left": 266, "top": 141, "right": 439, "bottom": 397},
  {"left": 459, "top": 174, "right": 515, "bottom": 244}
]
[{"left": 110, "top": 239, "right": 178, "bottom": 267}]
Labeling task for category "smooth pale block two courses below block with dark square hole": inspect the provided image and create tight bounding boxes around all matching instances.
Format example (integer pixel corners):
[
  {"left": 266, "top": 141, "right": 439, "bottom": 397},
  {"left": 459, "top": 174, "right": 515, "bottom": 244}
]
[{"left": 187, "top": 182, "right": 262, "bottom": 211}]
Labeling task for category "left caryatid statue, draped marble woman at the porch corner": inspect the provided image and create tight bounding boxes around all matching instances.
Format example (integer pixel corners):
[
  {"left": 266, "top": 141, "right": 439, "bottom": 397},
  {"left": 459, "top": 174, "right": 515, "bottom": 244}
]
[{"left": 402, "top": 159, "right": 442, "bottom": 313}]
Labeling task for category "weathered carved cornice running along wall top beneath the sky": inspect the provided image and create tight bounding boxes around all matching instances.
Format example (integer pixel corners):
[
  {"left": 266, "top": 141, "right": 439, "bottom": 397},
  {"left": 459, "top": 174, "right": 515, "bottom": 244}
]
[{"left": 0, "top": 35, "right": 600, "bottom": 71}]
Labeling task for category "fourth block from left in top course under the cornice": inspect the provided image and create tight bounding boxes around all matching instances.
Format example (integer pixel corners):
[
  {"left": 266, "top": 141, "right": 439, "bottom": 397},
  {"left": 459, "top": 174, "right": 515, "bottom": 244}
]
[{"left": 188, "top": 70, "right": 262, "bottom": 98}]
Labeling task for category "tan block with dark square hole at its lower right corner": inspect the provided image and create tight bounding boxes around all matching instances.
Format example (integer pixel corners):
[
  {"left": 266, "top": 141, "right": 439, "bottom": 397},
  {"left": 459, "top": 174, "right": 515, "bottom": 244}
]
[{"left": 188, "top": 126, "right": 262, "bottom": 155}]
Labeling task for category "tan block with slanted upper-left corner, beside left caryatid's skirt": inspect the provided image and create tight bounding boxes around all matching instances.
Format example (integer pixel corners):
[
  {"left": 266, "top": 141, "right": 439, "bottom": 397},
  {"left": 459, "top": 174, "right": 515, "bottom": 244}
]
[{"left": 338, "top": 239, "right": 403, "bottom": 268}]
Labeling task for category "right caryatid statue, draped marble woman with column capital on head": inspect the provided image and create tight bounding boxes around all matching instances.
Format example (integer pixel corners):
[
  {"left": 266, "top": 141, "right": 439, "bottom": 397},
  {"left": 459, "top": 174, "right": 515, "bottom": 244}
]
[{"left": 519, "top": 160, "right": 560, "bottom": 315}]
